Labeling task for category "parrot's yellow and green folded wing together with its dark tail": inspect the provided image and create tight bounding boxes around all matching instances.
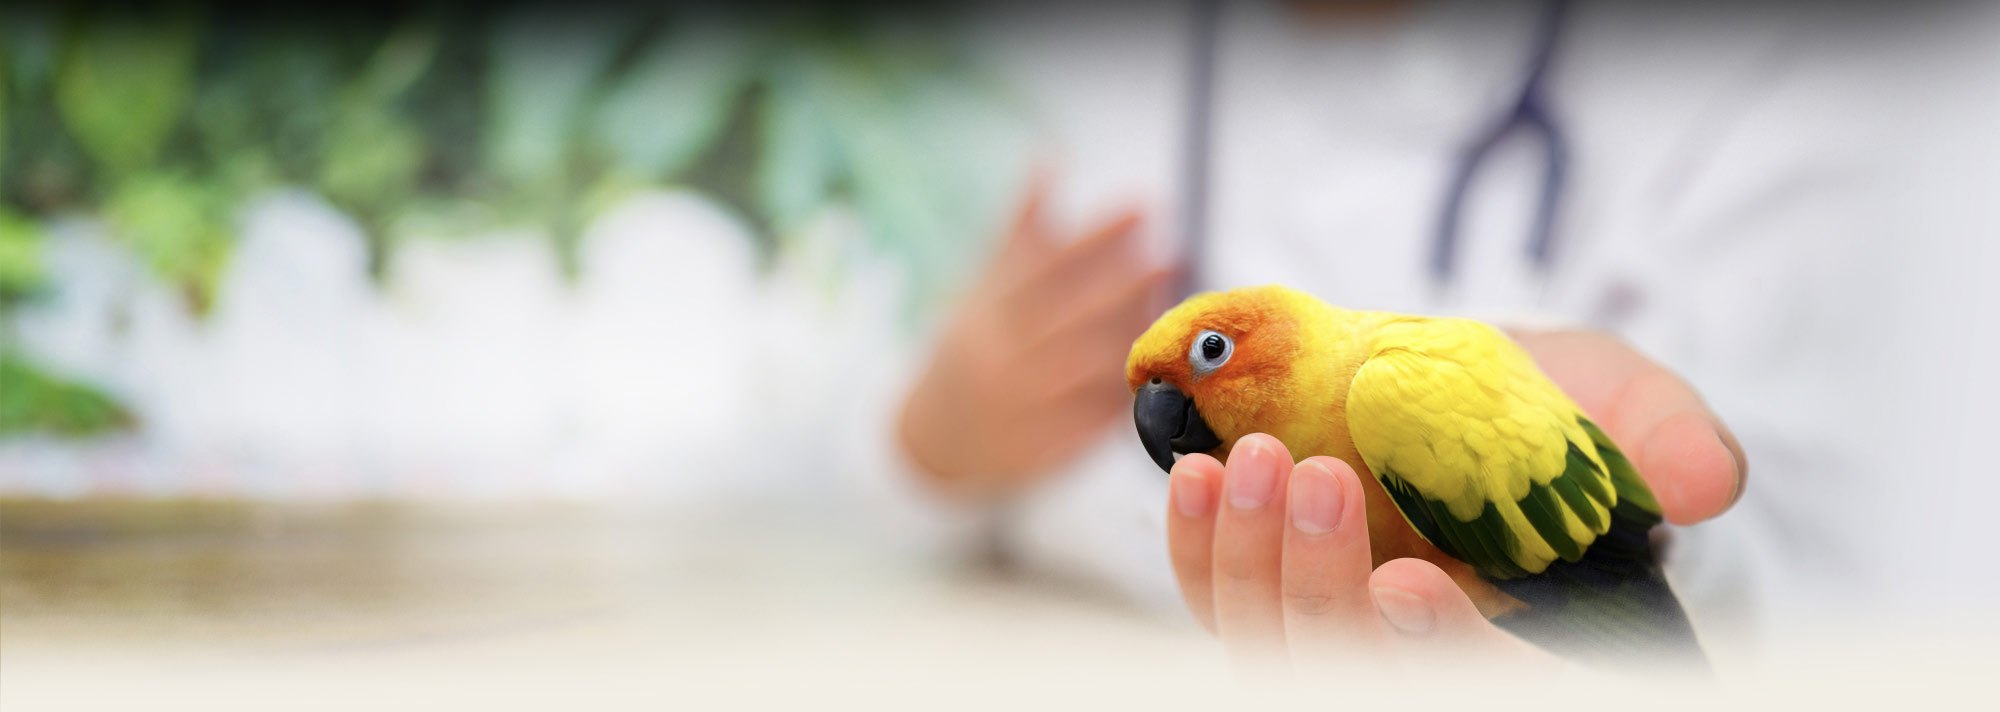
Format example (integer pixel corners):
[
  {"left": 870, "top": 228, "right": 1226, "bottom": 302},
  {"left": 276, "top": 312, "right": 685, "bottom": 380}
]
[{"left": 1346, "top": 320, "right": 1700, "bottom": 658}]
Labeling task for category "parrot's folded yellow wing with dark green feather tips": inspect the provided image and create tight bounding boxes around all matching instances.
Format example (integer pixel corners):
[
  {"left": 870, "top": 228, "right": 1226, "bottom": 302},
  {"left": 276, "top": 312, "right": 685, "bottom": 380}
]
[{"left": 1346, "top": 318, "right": 1616, "bottom": 578}]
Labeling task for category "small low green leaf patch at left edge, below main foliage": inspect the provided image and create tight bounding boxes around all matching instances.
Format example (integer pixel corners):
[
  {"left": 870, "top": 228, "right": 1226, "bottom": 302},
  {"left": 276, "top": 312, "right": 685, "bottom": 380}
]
[{"left": 0, "top": 352, "right": 134, "bottom": 438}]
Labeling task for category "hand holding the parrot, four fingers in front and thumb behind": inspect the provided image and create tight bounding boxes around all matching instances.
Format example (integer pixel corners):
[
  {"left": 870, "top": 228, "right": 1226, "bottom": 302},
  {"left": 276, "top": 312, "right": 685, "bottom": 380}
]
[{"left": 1168, "top": 332, "right": 1744, "bottom": 670}]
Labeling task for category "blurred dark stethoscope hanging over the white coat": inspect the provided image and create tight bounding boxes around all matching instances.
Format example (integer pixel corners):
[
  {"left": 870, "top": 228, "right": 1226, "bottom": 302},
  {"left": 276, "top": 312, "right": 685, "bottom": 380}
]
[{"left": 1178, "top": 0, "right": 1570, "bottom": 296}]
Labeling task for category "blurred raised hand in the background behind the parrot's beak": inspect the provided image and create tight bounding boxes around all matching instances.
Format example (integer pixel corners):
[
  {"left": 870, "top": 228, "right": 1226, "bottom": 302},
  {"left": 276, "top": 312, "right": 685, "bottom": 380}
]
[{"left": 898, "top": 178, "right": 1170, "bottom": 498}]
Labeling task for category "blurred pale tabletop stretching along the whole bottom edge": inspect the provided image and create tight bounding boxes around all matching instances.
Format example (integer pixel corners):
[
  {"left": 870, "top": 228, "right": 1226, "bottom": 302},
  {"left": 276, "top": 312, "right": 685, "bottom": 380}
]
[{"left": 0, "top": 500, "right": 1992, "bottom": 712}]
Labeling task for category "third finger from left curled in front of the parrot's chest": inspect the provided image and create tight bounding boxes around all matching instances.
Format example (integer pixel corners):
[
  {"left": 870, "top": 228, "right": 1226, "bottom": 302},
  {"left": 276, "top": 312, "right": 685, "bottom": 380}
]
[{"left": 1280, "top": 456, "right": 1382, "bottom": 660}]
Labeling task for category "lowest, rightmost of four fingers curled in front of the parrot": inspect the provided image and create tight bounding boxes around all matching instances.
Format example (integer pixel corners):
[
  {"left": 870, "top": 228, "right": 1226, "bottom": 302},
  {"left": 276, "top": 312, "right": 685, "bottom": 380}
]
[{"left": 1368, "top": 558, "right": 1550, "bottom": 660}]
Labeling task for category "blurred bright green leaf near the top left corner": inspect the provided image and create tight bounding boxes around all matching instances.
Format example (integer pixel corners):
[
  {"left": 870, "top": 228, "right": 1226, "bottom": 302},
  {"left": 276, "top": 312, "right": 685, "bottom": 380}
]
[{"left": 56, "top": 14, "right": 196, "bottom": 172}]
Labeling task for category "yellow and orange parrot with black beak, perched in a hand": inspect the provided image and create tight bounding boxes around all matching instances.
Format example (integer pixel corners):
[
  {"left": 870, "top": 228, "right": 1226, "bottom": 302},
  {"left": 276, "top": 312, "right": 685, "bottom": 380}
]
[{"left": 1126, "top": 286, "right": 1700, "bottom": 660}]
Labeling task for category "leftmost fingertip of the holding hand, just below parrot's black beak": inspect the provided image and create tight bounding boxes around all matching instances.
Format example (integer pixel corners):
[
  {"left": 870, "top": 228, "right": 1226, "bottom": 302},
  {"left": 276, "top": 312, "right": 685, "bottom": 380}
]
[{"left": 1166, "top": 454, "right": 1222, "bottom": 632}]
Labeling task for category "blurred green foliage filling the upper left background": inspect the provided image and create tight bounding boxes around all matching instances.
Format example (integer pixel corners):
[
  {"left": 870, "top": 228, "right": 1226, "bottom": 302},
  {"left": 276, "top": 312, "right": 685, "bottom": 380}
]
[{"left": 0, "top": 2, "right": 1014, "bottom": 434}]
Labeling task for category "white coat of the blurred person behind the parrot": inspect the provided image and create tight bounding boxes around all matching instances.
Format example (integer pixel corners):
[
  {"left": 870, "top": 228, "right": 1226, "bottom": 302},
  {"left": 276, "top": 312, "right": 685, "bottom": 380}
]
[{"left": 852, "top": 2, "right": 2000, "bottom": 660}]
